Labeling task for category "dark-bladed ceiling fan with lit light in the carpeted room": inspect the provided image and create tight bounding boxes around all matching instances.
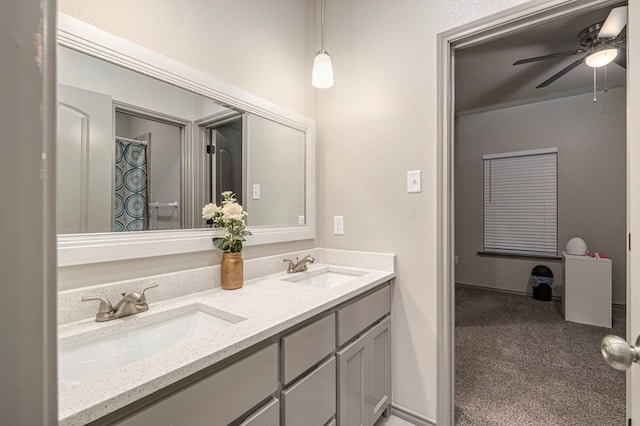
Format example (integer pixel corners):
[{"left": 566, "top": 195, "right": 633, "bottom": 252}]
[{"left": 513, "top": 6, "right": 627, "bottom": 89}]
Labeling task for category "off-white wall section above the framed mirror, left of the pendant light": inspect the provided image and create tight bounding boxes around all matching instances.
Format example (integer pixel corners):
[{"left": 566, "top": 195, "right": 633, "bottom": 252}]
[{"left": 58, "top": 0, "right": 316, "bottom": 117}]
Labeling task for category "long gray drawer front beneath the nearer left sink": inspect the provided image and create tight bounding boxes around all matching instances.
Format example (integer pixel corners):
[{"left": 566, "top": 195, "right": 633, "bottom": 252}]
[{"left": 118, "top": 344, "right": 278, "bottom": 426}]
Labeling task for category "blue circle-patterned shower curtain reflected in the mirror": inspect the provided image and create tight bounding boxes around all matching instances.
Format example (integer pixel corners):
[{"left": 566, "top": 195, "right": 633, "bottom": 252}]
[{"left": 113, "top": 138, "right": 147, "bottom": 232}]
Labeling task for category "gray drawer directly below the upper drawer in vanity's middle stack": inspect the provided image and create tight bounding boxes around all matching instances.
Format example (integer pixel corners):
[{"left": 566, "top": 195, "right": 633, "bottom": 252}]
[{"left": 281, "top": 357, "right": 336, "bottom": 426}]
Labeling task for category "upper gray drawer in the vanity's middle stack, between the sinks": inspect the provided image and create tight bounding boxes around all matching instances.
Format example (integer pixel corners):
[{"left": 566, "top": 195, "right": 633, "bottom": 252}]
[{"left": 282, "top": 314, "right": 336, "bottom": 385}]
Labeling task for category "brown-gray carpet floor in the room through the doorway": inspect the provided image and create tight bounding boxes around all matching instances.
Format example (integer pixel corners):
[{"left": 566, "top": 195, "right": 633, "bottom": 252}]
[{"left": 455, "top": 286, "right": 626, "bottom": 426}]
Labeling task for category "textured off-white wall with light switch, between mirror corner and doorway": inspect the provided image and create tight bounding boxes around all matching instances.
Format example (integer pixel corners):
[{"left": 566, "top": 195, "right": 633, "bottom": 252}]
[{"left": 318, "top": 0, "right": 536, "bottom": 419}]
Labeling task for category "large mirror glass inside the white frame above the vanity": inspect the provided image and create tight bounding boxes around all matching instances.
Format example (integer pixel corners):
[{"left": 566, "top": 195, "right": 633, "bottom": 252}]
[{"left": 56, "top": 46, "right": 305, "bottom": 234}]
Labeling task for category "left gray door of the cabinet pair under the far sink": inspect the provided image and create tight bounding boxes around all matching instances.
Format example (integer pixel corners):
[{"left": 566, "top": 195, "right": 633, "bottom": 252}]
[{"left": 336, "top": 334, "right": 369, "bottom": 426}]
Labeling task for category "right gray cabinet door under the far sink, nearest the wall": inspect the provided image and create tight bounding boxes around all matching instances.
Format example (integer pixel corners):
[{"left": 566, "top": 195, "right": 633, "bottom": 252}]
[{"left": 367, "top": 317, "right": 391, "bottom": 425}]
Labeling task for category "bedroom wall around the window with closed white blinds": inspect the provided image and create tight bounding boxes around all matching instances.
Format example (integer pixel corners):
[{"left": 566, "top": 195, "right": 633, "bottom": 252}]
[{"left": 455, "top": 87, "right": 626, "bottom": 304}]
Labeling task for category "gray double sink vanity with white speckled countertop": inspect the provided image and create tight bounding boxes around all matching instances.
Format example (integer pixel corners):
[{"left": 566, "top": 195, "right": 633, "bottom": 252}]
[{"left": 58, "top": 249, "right": 394, "bottom": 425}]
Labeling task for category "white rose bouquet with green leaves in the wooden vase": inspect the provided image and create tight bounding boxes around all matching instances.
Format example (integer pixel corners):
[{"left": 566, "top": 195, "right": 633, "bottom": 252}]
[{"left": 202, "top": 191, "right": 252, "bottom": 253}]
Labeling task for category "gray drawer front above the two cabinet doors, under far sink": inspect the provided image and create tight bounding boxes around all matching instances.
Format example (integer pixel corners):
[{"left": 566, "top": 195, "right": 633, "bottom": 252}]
[{"left": 338, "top": 284, "right": 391, "bottom": 346}]
